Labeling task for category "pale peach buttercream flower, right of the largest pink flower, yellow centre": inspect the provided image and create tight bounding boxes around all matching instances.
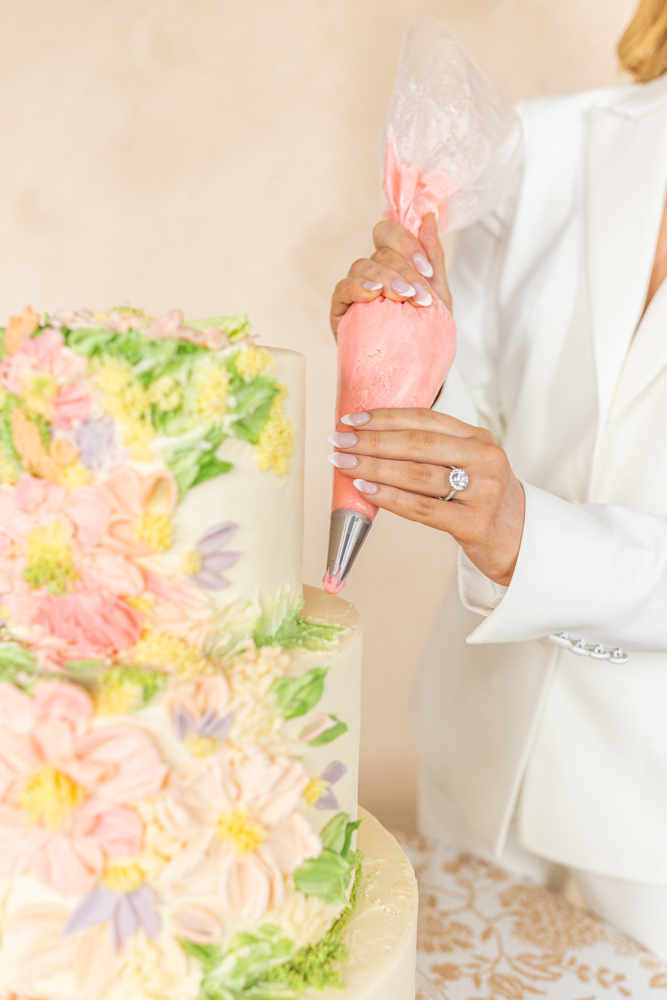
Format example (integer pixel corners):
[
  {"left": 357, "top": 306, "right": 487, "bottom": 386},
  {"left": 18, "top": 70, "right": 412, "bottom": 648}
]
[{"left": 159, "top": 747, "right": 322, "bottom": 920}]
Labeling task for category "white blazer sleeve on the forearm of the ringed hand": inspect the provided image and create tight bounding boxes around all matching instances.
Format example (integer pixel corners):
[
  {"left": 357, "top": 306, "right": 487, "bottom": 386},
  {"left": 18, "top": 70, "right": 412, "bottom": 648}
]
[{"left": 467, "top": 484, "right": 667, "bottom": 652}]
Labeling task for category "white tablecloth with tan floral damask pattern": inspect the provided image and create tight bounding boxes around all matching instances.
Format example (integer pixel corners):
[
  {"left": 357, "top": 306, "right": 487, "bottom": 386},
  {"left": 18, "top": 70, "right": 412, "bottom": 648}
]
[{"left": 398, "top": 834, "right": 667, "bottom": 1000}]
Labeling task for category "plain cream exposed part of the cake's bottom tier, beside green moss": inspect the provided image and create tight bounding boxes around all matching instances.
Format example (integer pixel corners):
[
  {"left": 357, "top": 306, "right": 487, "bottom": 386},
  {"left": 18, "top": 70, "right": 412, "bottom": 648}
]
[{"left": 318, "top": 808, "right": 417, "bottom": 1000}]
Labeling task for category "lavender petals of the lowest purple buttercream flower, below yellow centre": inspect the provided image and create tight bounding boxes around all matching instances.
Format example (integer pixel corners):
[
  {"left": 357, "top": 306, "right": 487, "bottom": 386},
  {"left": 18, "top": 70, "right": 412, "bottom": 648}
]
[{"left": 63, "top": 883, "right": 160, "bottom": 953}]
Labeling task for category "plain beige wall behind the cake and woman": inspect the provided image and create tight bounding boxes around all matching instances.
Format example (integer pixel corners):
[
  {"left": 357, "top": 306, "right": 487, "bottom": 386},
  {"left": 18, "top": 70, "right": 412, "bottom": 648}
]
[{"left": 0, "top": 0, "right": 634, "bottom": 827}]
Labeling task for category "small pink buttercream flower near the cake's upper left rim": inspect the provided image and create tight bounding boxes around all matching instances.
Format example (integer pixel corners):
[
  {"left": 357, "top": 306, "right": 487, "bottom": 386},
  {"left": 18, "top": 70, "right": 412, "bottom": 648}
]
[{"left": 0, "top": 328, "right": 93, "bottom": 429}]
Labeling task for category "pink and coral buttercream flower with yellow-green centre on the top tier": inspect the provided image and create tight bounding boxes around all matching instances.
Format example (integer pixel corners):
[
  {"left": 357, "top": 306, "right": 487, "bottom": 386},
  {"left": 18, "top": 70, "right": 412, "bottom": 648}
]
[{"left": 0, "top": 475, "right": 146, "bottom": 659}]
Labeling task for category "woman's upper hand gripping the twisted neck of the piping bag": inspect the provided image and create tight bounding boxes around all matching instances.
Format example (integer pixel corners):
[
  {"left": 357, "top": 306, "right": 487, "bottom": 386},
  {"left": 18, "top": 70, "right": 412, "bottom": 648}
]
[{"left": 331, "top": 213, "right": 452, "bottom": 335}]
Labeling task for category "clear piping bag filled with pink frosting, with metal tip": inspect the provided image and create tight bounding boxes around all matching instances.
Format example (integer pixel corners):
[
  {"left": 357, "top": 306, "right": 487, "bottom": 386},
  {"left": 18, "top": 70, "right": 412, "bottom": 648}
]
[{"left": 322, "top": 20, "right": 522, "bottom": 594}]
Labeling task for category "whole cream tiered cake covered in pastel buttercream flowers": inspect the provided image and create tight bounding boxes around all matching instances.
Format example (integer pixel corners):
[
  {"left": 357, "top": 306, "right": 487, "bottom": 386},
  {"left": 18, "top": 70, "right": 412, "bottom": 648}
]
[{"left": 0, "top": 308, "right": 416, "bottom": 1000}]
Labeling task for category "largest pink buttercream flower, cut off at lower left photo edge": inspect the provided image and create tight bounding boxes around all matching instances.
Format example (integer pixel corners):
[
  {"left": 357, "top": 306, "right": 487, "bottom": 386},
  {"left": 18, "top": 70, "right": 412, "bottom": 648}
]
[{"left": 0, "top": 681, "right": 166, "bottom": 894}]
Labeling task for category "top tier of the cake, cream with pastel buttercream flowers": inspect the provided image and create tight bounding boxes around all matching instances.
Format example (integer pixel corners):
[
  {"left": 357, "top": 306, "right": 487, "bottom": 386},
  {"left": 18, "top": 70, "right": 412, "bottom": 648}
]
[{"left": 0, "top": 307, "right": 303, "bottom": 666}]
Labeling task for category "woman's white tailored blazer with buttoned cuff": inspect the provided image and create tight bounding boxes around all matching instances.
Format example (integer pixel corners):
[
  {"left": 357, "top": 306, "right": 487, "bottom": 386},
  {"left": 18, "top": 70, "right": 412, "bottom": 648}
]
[{"left": 415, "top": 77, "right": 667, "bottom": 885}]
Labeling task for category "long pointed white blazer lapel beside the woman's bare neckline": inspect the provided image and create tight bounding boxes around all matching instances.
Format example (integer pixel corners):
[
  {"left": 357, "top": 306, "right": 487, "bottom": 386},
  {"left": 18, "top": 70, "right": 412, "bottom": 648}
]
[{"left": 584, "top": 85, "right": 667, "bottom": 426}]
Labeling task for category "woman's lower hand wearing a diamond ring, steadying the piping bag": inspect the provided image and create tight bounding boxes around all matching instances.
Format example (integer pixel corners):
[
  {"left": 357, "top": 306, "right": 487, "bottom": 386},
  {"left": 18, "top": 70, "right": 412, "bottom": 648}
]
[{"left": 327, "top": 410, "right": 525, "bottom": 586}]
